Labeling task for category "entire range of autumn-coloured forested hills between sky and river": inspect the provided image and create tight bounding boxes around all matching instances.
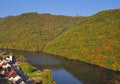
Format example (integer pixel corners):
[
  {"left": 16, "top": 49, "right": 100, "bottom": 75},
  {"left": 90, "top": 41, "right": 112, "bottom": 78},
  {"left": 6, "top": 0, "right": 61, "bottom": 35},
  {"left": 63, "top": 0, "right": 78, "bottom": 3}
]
[{"left": 0, "top": 9, "right": 120, "bottom": 71}]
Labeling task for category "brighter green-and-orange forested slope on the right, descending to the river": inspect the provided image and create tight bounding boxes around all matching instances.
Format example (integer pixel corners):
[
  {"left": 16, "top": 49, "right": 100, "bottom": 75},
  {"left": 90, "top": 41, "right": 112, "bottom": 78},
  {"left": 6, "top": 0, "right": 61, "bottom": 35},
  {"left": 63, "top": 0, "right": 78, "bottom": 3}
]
[{"left": 44, "top": 9, "right": 120, "bottom": 70}]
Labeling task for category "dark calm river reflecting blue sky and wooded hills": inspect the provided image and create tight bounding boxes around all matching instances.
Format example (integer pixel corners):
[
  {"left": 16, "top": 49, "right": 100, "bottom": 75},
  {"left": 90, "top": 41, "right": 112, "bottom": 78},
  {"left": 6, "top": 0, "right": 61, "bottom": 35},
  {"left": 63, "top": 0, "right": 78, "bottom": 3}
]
[{"left": 1, "top": 50, "right": 120, "bottom": 84}]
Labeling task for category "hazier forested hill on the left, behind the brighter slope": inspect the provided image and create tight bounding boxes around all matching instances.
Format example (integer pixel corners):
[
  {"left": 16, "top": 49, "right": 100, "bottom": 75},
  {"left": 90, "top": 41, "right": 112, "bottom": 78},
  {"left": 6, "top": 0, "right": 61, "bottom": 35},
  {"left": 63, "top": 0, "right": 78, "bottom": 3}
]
[{"left": 0, "top": 12, "right": 85, "bottom": 51}]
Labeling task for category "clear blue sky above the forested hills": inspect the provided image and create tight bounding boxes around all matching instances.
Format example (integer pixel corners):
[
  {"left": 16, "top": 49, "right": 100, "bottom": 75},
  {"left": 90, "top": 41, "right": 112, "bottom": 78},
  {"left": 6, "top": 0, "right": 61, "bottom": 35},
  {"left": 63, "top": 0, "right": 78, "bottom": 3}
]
[{"left": 0, "top": 0, "right": 120, "bottom": 18}]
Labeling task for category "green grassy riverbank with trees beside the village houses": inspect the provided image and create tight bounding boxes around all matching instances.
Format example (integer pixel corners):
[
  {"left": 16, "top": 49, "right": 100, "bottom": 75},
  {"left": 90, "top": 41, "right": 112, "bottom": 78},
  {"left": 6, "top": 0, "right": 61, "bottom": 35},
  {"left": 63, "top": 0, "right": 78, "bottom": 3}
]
[{"left": 3, "top": 55, "right": 56, "bottom": 84}]
